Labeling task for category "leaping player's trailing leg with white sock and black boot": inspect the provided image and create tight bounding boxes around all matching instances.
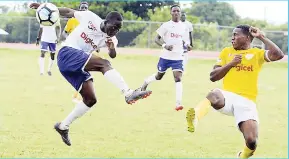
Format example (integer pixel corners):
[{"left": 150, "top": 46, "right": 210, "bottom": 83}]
[{"left": 54, "top": 80, "right": 96, "bottom": 146}]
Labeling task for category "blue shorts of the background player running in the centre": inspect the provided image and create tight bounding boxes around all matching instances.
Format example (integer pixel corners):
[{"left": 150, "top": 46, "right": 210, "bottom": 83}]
[{"left": 158, "top": 58, "right": 184, "bottom": 73}]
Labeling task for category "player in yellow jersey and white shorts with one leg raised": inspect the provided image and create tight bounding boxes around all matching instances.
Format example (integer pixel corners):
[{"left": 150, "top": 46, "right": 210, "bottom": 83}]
[{"left": 186, "top": 25, "right": 284, "bottom": 158}]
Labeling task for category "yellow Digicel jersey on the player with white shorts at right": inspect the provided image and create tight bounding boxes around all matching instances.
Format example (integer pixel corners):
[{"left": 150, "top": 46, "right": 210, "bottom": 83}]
[{"left": 216, "top": 47, "right": 265, "bottom": 102}]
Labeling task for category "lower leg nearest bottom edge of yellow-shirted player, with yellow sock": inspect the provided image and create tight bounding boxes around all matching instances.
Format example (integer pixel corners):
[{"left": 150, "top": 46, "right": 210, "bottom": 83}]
[{"left": 238, "top": 119, "right": 258, "bottom": 158}]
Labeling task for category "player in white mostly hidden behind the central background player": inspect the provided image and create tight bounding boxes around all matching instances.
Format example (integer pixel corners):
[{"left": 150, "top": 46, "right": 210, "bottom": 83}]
[{"left": 181, "top": 12, "right": 193, "bottom": 69}]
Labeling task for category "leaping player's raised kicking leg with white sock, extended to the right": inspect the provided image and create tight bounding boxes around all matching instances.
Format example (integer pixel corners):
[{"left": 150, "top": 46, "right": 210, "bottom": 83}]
[{"left": 84, "top": 54, "right": 152, "bottom": 104}]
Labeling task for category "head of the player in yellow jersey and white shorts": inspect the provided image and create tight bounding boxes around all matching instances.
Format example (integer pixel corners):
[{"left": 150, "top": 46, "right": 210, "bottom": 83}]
[{"left": 232, "top": 25, "right": 254, "bottom": 50}]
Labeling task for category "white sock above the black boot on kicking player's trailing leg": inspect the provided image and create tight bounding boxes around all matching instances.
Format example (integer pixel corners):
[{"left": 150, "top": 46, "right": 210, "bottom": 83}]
[{"left": 59, "top": 101, "right": 90, "bottom": 130}]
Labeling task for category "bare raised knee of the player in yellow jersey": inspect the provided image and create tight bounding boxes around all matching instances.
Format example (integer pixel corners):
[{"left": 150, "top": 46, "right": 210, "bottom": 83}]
[{"left": 206, "top": 89, "right": 225, "bottom": 110}]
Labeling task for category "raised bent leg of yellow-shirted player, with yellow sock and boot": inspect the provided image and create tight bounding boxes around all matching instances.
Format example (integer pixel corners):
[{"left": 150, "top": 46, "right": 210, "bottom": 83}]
[{"left": 186, "top": 89, "right": 225, "bottom": 132}]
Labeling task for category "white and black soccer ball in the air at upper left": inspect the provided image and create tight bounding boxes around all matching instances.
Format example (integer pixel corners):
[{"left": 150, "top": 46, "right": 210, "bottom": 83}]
[{"left": 36, "top": 3, "right": 59, "bottom": 26}]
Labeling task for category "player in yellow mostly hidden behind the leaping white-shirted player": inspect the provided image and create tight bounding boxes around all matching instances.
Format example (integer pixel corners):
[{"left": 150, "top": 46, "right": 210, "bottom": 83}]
[{"left": 62, "top": 2, "right": 88, "bottom": 39}]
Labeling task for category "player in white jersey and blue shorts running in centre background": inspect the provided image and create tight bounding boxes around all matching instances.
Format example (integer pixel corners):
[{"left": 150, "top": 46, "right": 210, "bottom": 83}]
[{"left": 141, "top": 5, "right": 190, "bottom": 111}]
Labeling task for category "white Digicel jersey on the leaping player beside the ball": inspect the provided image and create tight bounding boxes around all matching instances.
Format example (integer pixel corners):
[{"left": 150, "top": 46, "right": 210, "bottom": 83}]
[{"left": 62, "top": 11, "right": 118, "bottom": 53}]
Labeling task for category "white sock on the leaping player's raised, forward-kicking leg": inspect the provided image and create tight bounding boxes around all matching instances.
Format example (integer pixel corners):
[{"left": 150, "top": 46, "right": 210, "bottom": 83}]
[{"left": 104, "top": 69, "right": 132, "bottom": 96}]
